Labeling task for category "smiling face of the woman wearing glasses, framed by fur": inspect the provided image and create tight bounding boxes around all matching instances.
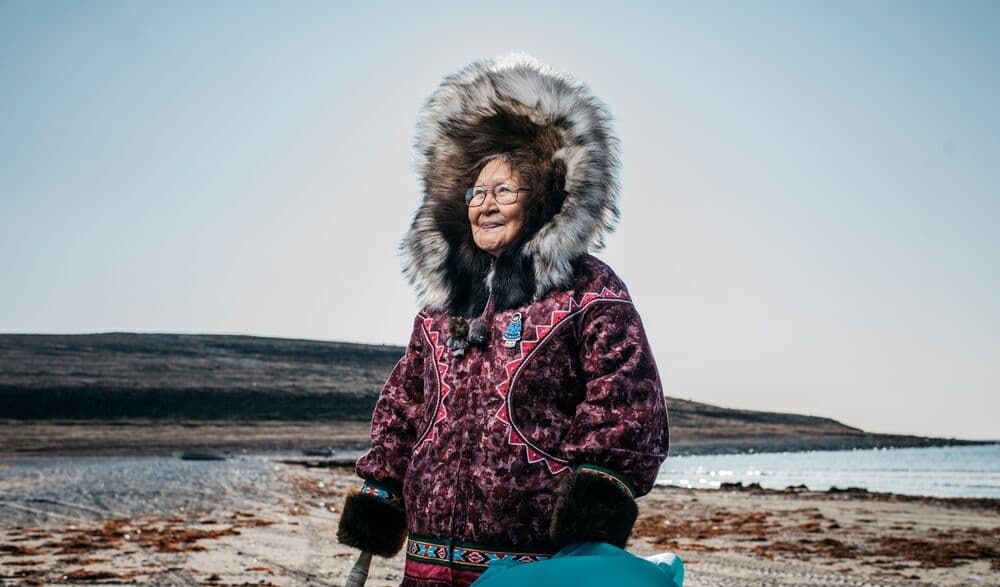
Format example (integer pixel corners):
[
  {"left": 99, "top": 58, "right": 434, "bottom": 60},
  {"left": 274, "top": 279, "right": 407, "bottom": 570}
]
[{"left": 469, "top": 159, "right": 524, "bottom": 257}]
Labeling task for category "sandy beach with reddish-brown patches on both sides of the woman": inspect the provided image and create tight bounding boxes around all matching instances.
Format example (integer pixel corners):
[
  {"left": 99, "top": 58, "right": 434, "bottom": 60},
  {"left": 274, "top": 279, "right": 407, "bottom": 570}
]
[{"left": 0, "top": 455, "right": 1000, "bottom": 587}]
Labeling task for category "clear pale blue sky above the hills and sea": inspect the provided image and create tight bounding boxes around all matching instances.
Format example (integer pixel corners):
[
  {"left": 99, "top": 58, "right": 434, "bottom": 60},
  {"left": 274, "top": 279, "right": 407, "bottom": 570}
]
[{"left": 0, "top": 0, "right": 1000, "bottom": 439}]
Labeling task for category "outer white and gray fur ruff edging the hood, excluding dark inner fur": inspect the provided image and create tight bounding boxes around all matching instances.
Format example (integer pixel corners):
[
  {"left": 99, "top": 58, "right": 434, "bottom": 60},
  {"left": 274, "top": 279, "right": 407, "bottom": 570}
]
[{"left": 400, "top": 53, "right": 620, "bottom": 310}]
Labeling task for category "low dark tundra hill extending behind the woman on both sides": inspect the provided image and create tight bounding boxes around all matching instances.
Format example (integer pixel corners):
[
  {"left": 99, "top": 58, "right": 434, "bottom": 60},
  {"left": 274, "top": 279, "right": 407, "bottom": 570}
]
[{"left": 0, "top": 332, "right": 976, "bottom": 454}]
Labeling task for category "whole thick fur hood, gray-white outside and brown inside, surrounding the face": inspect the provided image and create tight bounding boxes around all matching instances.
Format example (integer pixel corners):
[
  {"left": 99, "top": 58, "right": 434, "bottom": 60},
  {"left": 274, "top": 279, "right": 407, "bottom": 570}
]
[{"left": 400, "top": 54, "right": 619, "bottom": 316}]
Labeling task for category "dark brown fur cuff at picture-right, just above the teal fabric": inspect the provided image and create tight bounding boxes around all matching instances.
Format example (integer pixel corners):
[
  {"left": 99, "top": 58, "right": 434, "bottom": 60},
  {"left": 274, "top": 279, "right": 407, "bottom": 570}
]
[{"left": 549, "top": 470, "right": 639, "bottom": 548}]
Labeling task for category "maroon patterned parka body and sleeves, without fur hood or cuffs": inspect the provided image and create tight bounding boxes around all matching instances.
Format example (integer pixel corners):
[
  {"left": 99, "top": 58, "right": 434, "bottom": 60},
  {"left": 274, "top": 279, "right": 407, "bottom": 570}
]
[{"left": 357, "top": 255, "right": 668, "bottom": 587}]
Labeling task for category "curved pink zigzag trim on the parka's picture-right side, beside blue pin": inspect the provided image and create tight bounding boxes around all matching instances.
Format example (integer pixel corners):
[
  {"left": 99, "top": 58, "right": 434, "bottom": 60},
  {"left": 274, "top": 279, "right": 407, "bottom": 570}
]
[{"left": 494, "top": 288, "right": 631, "bottom": 475}]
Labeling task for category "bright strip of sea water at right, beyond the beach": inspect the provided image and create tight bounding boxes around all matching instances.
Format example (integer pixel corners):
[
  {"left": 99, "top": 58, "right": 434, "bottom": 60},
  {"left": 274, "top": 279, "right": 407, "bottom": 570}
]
[{"left": 657, "top": 444, "right": 1000, "bottom": 498}]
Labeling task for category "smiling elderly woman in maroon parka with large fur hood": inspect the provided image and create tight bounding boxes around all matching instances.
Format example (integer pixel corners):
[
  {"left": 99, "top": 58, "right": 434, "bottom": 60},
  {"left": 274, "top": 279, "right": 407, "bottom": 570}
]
[{"left": 338, "top": 55, "right": 668, "bottom": 587}]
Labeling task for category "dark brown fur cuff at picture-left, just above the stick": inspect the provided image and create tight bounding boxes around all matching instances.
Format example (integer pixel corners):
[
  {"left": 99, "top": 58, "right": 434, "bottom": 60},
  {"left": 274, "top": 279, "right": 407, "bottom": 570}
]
[{"left": 337, "top": 490, "right": 406, "bottom": 558}]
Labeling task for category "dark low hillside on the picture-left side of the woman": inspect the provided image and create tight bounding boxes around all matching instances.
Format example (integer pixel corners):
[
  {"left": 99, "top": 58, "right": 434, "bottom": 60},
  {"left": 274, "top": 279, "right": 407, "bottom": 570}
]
[{"left": 0, "top": 333, "right": 403, "bottom": 420}]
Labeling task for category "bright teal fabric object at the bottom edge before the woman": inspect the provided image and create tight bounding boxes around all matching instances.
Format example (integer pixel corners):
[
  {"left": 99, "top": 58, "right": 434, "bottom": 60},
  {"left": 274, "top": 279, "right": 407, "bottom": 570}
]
[{"left": 473, "top": 542, "right": 684, "bottom": 587}]
